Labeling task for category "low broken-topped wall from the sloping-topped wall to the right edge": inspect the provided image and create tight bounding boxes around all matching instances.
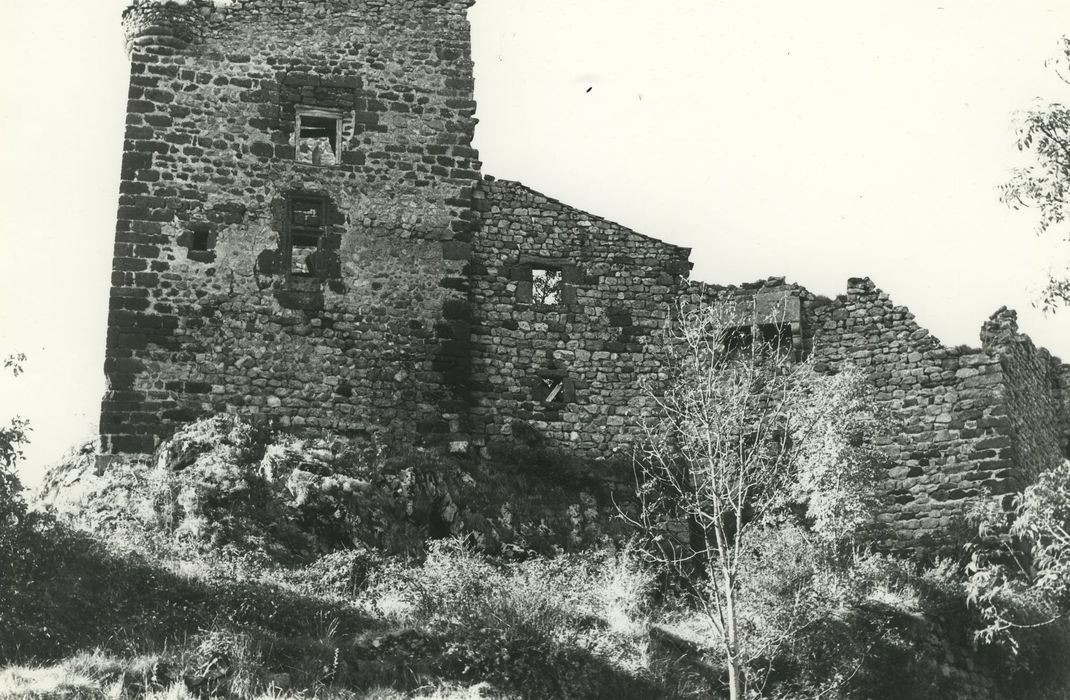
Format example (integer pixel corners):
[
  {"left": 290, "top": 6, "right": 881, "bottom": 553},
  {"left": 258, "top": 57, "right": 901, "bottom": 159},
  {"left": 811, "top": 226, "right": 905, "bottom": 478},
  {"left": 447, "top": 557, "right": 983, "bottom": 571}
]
[{"left": 689, "top": 277, "right": 1070, "bottom": 544}]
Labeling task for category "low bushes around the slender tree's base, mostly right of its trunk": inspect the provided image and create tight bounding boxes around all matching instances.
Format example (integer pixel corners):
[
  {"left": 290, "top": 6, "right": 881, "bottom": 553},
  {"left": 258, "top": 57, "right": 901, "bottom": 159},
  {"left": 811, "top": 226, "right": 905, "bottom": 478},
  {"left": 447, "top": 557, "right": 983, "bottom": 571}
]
[{"left": 655, "top": 527, "right": 1042, "bottom": 700}]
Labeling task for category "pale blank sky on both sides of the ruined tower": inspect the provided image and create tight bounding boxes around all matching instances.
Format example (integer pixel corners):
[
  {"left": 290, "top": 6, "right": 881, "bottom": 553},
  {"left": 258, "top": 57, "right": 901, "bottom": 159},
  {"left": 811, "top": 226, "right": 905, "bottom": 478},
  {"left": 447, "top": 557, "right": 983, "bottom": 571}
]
[{"left": 0, "top": 0, "right": 1070, "bottom": 484}]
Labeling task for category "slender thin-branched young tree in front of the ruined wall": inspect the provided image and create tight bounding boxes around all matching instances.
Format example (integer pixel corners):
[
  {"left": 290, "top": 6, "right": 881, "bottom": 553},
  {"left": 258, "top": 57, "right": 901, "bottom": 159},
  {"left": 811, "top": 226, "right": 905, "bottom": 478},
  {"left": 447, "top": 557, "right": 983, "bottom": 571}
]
[{"left": 637, "top": 305, "right": 875, "bottom": 700}]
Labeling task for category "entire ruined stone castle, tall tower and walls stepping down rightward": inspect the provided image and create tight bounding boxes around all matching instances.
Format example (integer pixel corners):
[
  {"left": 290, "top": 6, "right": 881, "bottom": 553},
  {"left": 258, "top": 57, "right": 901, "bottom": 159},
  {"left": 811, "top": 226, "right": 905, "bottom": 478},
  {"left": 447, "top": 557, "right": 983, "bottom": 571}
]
[{"left": 101, "top": 0, "right": 1070, "bottom": 539}]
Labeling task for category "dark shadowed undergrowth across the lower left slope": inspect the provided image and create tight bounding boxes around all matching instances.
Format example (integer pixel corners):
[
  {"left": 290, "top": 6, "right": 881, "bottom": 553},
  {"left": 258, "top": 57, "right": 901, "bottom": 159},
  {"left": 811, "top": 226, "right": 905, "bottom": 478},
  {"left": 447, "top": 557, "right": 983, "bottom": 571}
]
[{"left": 0, "top": 528, "right": 672, "bottom": 698}]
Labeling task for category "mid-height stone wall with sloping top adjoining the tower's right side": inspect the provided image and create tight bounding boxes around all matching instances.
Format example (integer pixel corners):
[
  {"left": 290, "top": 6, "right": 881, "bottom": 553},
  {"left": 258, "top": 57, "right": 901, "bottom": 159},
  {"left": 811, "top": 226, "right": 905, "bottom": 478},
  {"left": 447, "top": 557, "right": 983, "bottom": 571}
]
[{"left": 469, "top": 180, "right": 690, "bottom": 457}]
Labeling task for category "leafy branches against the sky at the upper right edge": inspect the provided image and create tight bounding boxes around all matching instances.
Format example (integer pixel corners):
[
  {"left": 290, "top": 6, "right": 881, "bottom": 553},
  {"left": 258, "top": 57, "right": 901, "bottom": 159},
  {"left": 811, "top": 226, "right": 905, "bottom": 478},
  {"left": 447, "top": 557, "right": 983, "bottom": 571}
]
[{"left": 1002, "top": 36, "right": 1070, "bottom": 309}]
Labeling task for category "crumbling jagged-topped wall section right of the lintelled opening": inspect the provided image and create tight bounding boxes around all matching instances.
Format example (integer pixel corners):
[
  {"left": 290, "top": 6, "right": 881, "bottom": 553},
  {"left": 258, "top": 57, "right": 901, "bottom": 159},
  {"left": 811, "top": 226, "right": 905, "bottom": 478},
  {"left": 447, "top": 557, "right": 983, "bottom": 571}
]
[{"left": 804, "top": 278, "right": 1060, "bottom": 541}]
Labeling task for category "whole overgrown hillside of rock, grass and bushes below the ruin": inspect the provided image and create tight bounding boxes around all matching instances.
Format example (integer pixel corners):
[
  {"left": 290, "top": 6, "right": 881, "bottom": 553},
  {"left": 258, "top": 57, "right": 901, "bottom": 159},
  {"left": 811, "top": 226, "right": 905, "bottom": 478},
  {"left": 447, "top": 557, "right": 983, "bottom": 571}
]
[{"left": 0, "top": 417, "right": 1068, "bottom": 699}]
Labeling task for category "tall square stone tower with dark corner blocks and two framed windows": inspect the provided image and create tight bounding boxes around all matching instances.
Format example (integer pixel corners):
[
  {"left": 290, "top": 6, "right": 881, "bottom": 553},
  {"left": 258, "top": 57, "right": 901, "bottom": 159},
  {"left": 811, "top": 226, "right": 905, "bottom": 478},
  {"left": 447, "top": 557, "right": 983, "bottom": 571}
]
[{"left": 101, "top": 0, "right": 479, "bottom": 452}]
